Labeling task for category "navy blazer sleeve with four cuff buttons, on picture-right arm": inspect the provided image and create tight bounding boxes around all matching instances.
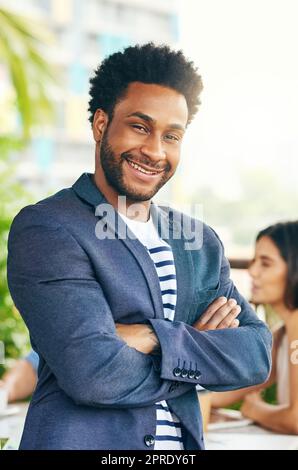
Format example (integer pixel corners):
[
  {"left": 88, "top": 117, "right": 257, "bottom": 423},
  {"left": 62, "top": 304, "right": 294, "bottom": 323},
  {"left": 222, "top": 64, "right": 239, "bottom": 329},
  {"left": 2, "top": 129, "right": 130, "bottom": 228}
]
[{"left": 150, "top": 228, "right": 272, "bottom": 391}]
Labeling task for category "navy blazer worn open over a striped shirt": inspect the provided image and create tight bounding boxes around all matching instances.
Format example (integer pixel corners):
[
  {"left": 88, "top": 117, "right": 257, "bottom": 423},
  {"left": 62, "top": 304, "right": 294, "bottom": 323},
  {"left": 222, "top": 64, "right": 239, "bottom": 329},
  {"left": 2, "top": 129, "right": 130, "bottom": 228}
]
[{"left": 8, "top": 173, "right": 271, "bottom": 450}]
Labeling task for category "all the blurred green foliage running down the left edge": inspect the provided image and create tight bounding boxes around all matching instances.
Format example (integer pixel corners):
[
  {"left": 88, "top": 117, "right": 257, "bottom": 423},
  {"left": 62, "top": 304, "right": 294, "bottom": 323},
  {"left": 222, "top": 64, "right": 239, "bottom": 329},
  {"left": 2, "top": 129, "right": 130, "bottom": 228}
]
[{"left": 0, "top": 8, "right": 57, "bottom": 375}]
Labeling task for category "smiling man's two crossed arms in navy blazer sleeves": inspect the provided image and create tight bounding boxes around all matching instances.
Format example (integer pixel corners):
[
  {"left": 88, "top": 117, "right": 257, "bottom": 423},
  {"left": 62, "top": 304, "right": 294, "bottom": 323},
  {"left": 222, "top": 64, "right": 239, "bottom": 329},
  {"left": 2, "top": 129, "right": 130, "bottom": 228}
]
[{"left": 8, "top": 206, "right": 271, "bottom": 408}]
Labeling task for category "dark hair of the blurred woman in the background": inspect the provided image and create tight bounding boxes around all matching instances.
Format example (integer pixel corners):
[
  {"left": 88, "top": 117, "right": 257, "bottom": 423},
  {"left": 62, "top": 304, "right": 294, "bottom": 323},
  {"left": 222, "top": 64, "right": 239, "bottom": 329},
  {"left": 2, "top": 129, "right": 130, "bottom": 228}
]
[{"left": 256, "top": 220, "right": 298, "bottom": 310}]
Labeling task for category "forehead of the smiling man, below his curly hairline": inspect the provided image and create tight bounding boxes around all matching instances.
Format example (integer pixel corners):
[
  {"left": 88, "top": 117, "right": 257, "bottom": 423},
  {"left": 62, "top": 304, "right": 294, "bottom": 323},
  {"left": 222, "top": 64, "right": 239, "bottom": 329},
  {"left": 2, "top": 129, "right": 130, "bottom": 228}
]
[{"left": 114, "top": 82, "right": 188, "bottom": 127}]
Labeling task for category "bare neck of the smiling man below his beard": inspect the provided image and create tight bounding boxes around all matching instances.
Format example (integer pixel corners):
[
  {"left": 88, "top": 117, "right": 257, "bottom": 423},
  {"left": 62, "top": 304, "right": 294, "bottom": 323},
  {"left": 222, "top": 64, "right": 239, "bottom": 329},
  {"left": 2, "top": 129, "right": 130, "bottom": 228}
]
[{"left": 92, "top": 166, "right": 150, "bottom": 222}]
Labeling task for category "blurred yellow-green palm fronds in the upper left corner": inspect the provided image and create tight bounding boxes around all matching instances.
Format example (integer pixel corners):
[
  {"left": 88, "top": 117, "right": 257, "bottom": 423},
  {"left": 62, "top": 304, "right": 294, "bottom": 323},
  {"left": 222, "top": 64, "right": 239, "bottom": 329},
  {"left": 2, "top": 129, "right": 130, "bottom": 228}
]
[{"left": 0, "top": 8, "right": 55, "bottom": 145}]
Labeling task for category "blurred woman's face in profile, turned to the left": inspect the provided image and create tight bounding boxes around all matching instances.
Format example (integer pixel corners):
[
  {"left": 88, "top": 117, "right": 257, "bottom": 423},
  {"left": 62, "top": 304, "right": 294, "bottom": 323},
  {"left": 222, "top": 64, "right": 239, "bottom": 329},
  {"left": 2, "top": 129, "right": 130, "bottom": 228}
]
[{"left": 248, "top": 236, "right": 287, "bottom": 305}]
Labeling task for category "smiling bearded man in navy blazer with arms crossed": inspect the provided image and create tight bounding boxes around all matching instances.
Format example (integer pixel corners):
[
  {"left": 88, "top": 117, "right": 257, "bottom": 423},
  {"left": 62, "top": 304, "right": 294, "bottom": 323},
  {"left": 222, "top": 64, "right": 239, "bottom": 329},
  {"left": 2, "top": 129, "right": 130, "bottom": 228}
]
[{"left": 8, "top": 43, "right": 271, "bottom": 450}]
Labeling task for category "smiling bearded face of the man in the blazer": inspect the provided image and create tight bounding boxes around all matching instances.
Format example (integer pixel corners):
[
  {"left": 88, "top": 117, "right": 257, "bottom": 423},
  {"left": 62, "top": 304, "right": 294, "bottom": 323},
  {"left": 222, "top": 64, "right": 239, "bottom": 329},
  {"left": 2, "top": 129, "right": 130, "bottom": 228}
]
[{"left": 95, "top": 82, "right": 188, "bottom": 201}]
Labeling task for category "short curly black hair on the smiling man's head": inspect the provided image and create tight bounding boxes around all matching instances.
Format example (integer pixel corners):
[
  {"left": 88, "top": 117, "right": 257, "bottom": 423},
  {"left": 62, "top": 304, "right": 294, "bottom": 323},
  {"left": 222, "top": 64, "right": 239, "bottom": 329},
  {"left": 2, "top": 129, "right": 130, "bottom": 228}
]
[{"left": 88, "top": 42, "right": 203, "bottom": 124}]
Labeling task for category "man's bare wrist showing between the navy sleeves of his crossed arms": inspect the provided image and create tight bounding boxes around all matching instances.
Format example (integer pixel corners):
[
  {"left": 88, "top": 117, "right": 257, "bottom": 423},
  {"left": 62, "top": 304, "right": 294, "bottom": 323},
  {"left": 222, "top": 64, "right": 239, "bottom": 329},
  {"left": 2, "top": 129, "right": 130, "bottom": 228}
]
[{"left": 116, "top": 323, "right": 159, "bottom": 354}]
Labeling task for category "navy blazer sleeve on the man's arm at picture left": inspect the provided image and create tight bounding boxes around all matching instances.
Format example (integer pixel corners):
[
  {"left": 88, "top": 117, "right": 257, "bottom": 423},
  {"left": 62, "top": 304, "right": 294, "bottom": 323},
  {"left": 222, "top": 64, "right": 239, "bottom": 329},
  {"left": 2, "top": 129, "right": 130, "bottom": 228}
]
[{"left": 7, "top": 206, "right": 193, "bottom": 408}]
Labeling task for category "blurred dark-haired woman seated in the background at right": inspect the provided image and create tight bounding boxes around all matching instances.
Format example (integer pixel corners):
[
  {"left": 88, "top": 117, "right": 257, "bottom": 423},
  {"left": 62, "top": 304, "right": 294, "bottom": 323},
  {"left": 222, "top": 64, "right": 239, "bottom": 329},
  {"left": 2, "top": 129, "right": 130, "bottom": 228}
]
[{"left": 212, "top": 221, "right": 298, "bottom": 435}]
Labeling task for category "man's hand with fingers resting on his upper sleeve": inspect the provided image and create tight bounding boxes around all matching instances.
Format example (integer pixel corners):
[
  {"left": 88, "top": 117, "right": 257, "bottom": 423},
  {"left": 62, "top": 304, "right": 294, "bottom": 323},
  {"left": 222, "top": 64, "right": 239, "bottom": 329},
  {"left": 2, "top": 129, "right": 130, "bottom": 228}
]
[{"left": 193, "top": 297, "right": 241, "bottom": 331}]
